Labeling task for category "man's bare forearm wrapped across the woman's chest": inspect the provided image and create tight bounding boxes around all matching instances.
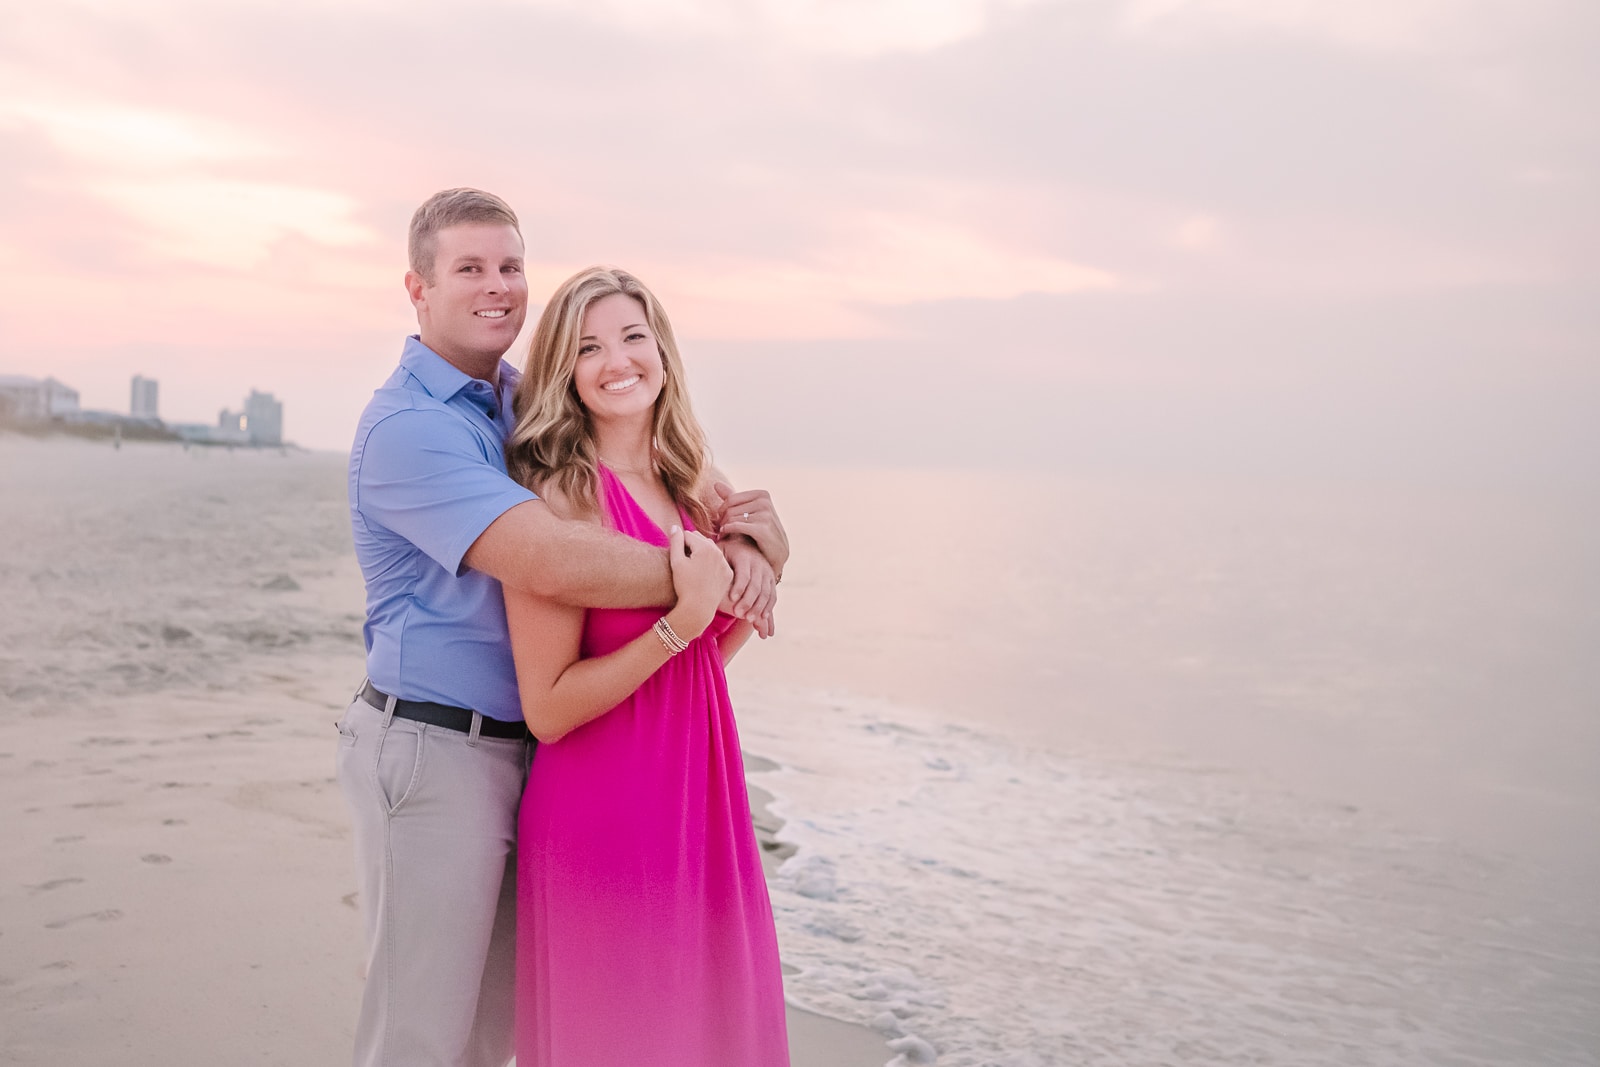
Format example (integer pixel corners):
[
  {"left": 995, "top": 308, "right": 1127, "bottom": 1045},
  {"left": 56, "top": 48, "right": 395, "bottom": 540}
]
[{"left": 466, "top": 501, "right": 677, "bottom": 608}]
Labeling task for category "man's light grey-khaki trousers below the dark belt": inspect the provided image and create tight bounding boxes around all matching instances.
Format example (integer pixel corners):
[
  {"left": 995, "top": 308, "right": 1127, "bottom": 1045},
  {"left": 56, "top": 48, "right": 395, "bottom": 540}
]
[{"left": 338, "top": 687, "right": 530, "bottom": 1067}]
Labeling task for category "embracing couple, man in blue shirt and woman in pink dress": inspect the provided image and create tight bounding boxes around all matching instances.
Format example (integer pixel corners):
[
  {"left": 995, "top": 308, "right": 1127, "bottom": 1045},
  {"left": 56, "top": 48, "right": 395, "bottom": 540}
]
[{"left": 338, "top": 189, "right": 789, "bottom": 1067}]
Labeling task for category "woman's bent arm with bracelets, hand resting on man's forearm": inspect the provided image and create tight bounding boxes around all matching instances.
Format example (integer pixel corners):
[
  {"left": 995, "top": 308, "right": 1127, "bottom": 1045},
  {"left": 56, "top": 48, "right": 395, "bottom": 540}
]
[{"left": 506, "top": 528, "right": 733, "bottom": 742}]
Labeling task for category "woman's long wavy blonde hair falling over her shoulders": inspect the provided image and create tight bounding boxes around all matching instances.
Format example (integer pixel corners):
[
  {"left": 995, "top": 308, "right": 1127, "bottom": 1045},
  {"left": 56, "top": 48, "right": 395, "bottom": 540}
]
[{"left": 506, "top": 267, "right": 714, "bottom": 534}]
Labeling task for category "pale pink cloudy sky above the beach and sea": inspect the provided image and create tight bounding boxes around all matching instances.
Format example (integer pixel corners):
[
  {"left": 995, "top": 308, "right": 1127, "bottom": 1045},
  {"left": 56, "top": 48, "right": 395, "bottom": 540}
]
[{"left": 0, "top": 0, "right": 1600, "bottom": 476}]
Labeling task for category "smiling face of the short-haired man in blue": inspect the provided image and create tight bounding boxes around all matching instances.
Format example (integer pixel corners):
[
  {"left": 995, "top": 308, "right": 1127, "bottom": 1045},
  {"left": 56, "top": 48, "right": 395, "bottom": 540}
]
[{"left": 405, "top": 222, "right": 528, "bottom": 378}]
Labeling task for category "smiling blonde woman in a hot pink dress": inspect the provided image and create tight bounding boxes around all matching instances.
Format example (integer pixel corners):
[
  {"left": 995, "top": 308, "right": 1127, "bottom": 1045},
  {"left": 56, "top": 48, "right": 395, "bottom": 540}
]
[{"left": 506, "top": 267, "right": 789, "bottom": 1067}]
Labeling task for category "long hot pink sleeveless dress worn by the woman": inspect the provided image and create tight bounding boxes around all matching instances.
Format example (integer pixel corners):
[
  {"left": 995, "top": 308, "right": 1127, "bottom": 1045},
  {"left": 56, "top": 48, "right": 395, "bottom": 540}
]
[{"left": 517, "top": 467, "right": 789, "bottom": 1067}]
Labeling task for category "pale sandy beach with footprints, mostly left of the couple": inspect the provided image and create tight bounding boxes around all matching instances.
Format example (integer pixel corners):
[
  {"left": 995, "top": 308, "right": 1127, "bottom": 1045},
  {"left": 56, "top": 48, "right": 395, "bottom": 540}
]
[{"left": 0, "top": 440, "right": 893, "bottom": 1067}]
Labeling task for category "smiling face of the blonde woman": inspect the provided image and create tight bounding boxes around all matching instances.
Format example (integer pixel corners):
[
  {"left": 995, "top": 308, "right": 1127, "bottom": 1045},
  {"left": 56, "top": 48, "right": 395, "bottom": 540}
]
[{"left": 573, "top": 293, "right": 666, "bottom": 419}]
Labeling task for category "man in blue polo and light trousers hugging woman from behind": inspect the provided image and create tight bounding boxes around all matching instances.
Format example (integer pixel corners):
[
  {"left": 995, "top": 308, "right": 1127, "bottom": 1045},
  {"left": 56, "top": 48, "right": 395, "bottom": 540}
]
[{"left": 338, "top": 189, "right": 789, "bottom": 1067}]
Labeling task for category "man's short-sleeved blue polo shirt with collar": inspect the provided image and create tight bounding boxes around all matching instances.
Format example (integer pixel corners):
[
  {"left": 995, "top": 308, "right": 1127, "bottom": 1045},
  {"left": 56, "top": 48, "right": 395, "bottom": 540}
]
[{"left": 350, "top": 336, "right": 536, "bottom": 721}]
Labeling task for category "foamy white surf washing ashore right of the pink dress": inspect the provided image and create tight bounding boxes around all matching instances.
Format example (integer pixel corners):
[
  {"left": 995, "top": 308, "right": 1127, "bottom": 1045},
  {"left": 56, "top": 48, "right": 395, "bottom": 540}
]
[{"left": 741, "top": 693, "right": 1600, "bottom": 1067}]
